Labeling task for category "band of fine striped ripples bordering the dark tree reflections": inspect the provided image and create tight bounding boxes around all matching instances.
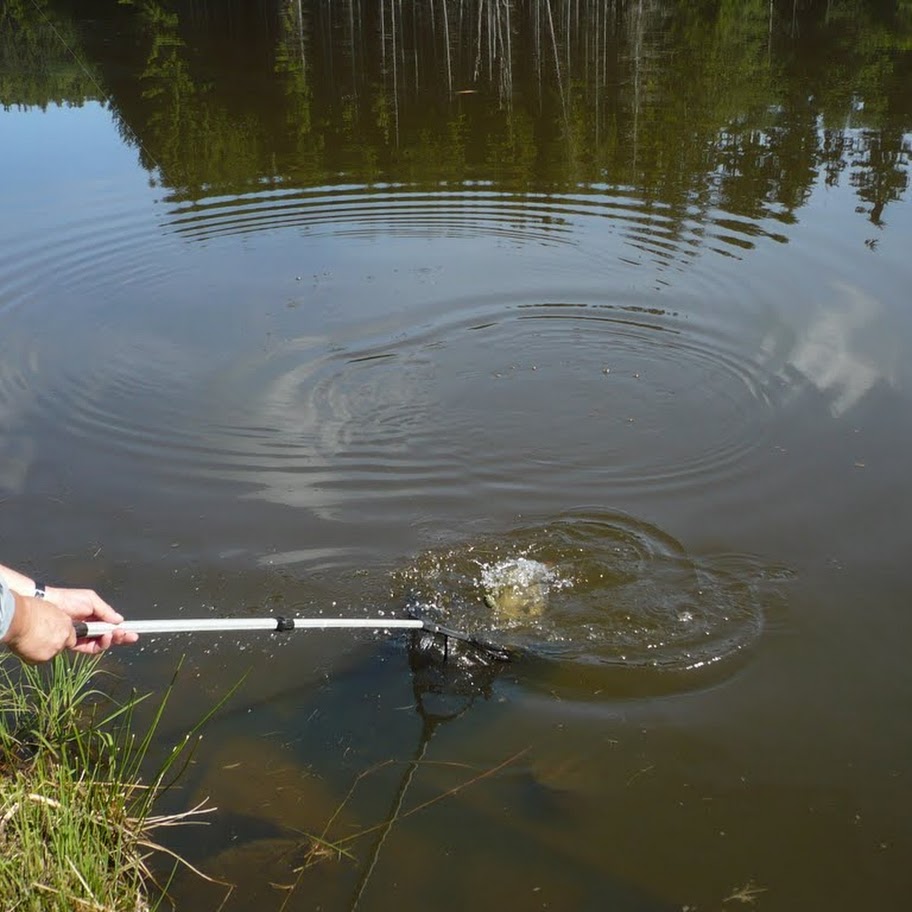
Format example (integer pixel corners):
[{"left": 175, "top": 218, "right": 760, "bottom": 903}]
[{"left": 160, "top": 183, "right": 787, "bottom": 265}]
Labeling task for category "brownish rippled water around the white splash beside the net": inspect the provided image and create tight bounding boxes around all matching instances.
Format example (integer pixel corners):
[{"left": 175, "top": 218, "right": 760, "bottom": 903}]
[{"left": 395, "top": 511, "right": 787, "bottom": 689}]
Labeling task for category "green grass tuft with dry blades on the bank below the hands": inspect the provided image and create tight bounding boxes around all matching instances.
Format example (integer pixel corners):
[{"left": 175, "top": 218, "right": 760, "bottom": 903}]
[{"left": 0, "top": 654, "right": 233, "bottom": 912}]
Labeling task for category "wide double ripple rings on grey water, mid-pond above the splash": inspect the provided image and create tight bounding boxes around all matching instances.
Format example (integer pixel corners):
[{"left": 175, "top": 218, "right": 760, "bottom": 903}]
[{"left": 0, "top": 300, "right": 792, "bottom": 512}]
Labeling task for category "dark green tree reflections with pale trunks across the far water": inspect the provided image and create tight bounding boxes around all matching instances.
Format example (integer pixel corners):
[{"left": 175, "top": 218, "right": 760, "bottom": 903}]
[{"left": 0, "top": 0, "right": 912, "bottom": 230}]
